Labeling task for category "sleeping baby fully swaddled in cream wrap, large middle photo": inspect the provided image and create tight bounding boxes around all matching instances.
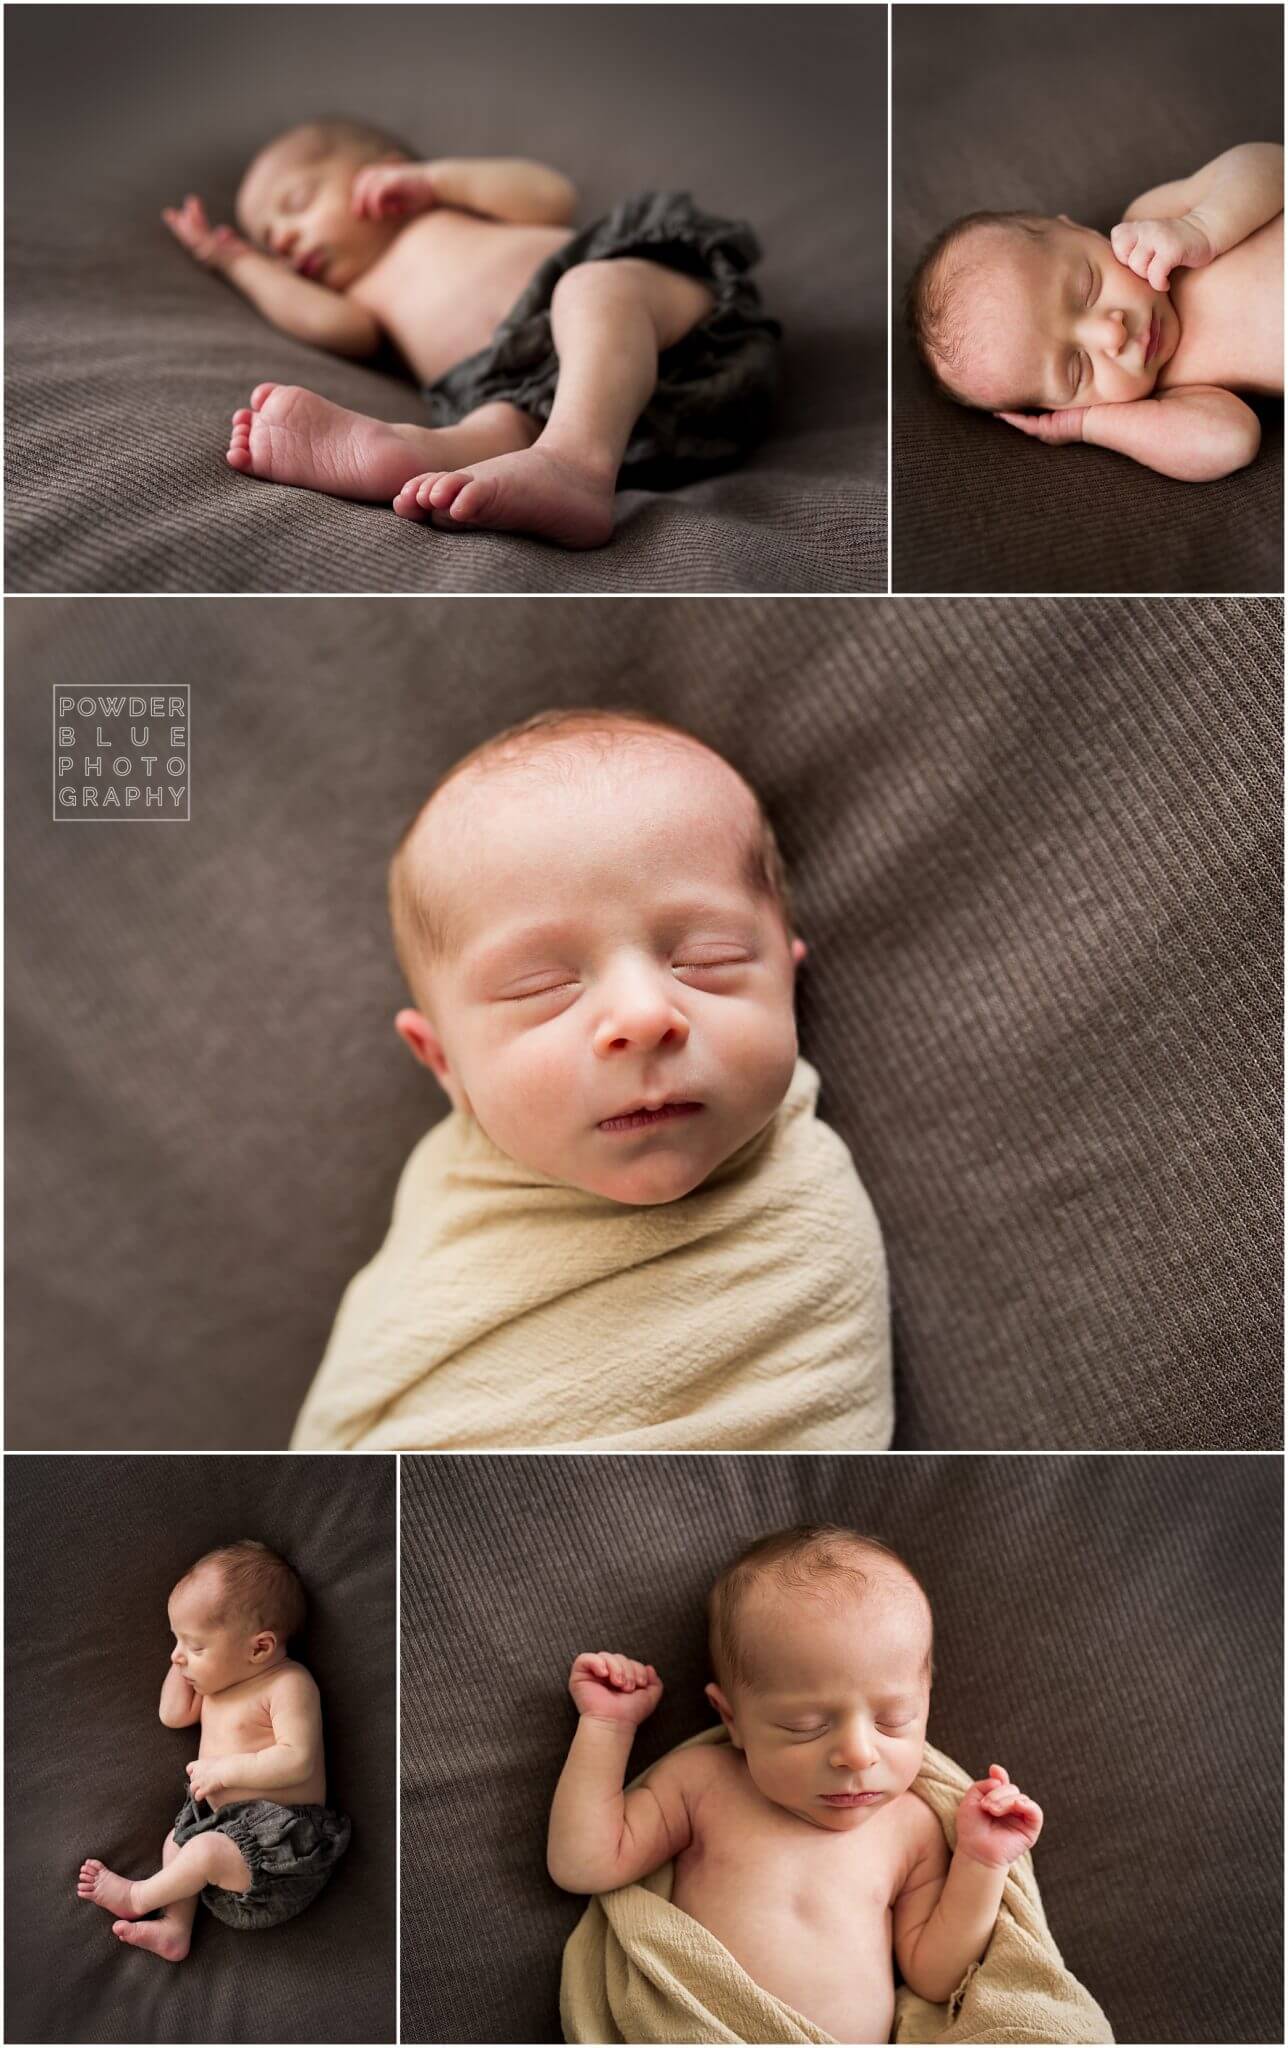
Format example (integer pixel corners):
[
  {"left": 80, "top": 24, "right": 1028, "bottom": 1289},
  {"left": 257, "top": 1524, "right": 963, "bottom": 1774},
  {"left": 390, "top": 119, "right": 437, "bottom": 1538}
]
[{"left": 293, "top": 711, "right": 891, "bottom": 1450}]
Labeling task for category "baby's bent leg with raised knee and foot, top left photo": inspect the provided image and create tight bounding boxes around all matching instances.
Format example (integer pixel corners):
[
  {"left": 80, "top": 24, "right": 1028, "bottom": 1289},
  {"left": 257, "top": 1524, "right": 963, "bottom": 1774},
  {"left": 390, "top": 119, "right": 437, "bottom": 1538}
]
[{"left": 393, "top": 256, "right": 715, "bottom": 547}]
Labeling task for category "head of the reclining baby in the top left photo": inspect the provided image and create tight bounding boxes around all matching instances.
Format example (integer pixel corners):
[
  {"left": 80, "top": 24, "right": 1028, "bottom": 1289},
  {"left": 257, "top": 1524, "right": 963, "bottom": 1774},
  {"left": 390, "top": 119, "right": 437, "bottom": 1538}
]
[{"left": 235, "top": 119, "right": 410, "bottom": 291}]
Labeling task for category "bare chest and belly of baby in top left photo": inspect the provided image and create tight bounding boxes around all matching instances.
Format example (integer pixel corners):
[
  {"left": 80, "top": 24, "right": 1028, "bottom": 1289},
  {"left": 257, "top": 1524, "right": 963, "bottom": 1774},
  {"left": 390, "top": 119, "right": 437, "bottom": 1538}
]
[{"left": 350, "top": 207, "right": 573, "bottom": 385}]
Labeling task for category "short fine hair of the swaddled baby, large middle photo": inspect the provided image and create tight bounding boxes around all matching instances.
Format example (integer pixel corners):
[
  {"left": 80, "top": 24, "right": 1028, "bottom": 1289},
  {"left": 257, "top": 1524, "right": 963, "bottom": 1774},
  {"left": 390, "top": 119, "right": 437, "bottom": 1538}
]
[{"left": 389, "top": 707, "right": 792, "bottom": 1011}]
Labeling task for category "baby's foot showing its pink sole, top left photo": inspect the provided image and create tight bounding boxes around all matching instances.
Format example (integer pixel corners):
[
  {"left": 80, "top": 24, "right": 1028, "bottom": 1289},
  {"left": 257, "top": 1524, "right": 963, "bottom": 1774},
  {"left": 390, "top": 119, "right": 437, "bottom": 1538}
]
[{"left": 227, "top": 385, "right": 440, "bottom": 500}]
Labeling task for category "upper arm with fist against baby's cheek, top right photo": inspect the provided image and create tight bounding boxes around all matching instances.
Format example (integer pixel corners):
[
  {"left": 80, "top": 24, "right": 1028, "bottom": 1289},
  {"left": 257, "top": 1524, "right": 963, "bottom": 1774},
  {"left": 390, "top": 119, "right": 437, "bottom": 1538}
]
[{"left": 1110, "top": 141, "right": 1284, "bottom": 291}]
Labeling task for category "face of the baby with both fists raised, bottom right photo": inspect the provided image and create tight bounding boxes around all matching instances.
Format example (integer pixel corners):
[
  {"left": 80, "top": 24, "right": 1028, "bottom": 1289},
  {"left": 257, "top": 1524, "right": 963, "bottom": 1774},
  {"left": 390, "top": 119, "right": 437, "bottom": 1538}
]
[{"left": 715, "top": 1579, "right": 930, "bottom": 1833}]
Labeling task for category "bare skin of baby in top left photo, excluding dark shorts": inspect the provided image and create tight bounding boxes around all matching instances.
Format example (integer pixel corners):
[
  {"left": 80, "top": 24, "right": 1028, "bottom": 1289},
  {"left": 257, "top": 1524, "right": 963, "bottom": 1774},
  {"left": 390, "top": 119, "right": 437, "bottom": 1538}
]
[{"left": 164, "top": 131, "right": 715, "bottom": 547}]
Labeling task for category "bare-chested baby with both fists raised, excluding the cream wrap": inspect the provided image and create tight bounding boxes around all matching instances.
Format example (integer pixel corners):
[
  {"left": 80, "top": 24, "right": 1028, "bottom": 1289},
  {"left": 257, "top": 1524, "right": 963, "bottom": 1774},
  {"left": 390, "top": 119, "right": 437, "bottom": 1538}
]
[{"left": 549, "top": 1528, "right": 1042, "bottom": 2042}]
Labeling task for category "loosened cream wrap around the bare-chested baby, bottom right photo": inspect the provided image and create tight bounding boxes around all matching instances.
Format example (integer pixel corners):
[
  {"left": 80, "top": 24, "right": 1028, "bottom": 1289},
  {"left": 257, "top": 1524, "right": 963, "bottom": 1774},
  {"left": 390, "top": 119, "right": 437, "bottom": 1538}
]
[{"left": 559, "top": 1729, "right": 1114, "bottom": 2048}]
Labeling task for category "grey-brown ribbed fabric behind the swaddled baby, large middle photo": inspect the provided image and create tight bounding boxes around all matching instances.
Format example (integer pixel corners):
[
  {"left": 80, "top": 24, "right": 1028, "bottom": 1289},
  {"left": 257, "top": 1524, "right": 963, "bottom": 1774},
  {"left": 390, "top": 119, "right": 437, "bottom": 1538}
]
[{"left": 6, "top": 600, "right": 1282, "bottom": 1450}]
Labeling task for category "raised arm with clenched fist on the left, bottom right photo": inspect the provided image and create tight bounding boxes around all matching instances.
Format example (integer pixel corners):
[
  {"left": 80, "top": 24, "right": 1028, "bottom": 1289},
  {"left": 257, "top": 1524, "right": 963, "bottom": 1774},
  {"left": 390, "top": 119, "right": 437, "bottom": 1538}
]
[{"left": 547, "top": 1651, "right": 692, "bottom": 1892}]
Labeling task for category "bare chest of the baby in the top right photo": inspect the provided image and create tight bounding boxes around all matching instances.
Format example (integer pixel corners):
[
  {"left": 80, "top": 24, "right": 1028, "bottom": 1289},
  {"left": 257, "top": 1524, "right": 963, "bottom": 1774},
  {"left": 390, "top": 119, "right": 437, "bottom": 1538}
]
[{"left": 1159, "top": 213, "right": 1284, "bottom": 393}]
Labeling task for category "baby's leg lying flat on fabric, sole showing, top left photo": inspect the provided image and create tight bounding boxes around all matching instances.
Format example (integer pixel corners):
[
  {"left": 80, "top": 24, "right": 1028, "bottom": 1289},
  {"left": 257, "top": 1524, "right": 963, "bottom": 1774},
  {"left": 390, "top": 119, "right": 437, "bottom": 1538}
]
[{"left": 227, "top": 385, "right": 536, "bottom": 502}]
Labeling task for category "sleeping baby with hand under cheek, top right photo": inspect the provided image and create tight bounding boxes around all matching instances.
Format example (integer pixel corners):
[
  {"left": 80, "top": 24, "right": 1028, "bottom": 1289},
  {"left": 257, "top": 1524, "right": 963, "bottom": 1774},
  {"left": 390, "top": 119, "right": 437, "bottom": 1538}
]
[{"left": 907, "top": 143, "right": 1284, "bottom": 483}]
